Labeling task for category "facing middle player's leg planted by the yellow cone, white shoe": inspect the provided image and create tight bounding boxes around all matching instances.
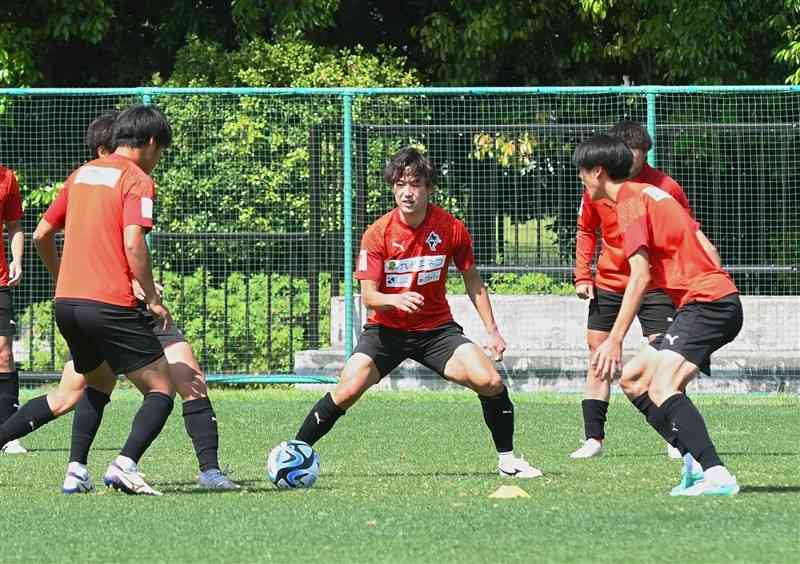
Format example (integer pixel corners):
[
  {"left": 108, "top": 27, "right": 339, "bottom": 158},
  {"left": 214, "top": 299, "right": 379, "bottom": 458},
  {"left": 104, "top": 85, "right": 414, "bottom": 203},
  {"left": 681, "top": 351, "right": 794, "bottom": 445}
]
[{"left": 411, "top": 323, "right": 542, "bottom": 478}]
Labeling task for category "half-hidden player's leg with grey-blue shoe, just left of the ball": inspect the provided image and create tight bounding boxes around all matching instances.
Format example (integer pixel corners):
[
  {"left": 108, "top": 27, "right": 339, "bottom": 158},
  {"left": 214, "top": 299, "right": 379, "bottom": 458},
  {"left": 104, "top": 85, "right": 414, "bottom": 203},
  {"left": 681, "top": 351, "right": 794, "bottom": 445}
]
[{"left": 161, "top": 340, "right": 239, "bottom": 490}]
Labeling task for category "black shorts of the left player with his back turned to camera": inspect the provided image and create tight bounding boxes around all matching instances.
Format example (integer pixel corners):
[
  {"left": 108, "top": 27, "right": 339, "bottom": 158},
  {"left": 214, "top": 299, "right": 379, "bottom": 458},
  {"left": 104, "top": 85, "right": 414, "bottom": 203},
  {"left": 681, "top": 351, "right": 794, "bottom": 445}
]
[{"left": 55, "top": 299, "right": 164, "bottom": 374}]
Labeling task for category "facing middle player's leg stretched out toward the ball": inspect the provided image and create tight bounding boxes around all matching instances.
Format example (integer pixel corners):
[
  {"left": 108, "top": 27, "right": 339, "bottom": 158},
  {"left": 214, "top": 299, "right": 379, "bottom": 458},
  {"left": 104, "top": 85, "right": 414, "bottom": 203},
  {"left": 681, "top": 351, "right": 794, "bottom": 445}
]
[{"left": 295, "top": 325, "right": 400, "bottom": 446}]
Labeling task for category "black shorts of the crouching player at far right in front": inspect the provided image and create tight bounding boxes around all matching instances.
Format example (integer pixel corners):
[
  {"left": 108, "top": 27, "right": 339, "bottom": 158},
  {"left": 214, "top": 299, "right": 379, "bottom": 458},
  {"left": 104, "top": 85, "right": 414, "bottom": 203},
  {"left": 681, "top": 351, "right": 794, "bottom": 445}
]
[{"left": 653, "top": 294, "right": 744, "bottom": 374}]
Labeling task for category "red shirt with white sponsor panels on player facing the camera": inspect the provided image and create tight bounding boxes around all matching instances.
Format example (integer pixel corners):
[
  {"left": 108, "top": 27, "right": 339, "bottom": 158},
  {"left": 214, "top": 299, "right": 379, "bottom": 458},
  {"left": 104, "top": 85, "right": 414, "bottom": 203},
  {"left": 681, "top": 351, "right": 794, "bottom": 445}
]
[{"left": 356, "top": 204, "right": 475, "bottom": 331}]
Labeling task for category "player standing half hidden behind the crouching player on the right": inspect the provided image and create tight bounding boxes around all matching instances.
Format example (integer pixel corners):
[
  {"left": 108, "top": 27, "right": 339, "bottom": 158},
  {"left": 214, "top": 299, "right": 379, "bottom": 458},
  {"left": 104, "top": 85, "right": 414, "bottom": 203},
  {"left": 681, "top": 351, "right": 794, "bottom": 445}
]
[{"left": 570, "top": 120, "right": 708, "bottom": 458}]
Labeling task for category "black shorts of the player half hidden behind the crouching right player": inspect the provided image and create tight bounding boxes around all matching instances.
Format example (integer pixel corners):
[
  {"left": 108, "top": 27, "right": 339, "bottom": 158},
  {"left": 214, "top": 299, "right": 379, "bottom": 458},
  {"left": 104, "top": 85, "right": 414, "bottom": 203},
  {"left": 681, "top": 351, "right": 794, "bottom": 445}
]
[{"left": 587, "top": 286, "right": 675, "bottom": 337}]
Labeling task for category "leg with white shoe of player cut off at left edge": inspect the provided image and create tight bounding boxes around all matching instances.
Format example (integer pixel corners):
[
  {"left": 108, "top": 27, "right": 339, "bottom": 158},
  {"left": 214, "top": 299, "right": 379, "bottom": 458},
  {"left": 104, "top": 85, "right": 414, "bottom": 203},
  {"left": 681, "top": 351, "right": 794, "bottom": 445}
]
[{"left": 0, "top": 287, "right": 23, "bottom": 454}]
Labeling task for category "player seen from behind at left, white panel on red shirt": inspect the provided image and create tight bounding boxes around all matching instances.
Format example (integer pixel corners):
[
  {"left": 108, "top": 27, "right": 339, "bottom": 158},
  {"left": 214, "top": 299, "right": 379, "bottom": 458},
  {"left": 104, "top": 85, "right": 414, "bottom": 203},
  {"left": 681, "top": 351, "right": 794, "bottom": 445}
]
[{"left": 35, "top": 105, "right": 175, "bottom": 495}]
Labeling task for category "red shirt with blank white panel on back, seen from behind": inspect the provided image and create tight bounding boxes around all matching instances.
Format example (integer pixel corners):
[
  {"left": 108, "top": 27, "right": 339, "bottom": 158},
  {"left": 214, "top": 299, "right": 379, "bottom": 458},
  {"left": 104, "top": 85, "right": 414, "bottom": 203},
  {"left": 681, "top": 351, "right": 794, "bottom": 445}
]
[{"left": 44, "top": 155, "right": 155, "bottom": 307}]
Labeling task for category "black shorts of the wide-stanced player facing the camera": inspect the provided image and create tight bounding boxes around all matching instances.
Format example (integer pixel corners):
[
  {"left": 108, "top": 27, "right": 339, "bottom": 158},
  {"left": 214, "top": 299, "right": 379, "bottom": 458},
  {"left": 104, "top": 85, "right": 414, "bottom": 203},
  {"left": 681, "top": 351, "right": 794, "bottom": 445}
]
[{"left": 353, "top": 323, "right": 472, "bottom": 378}]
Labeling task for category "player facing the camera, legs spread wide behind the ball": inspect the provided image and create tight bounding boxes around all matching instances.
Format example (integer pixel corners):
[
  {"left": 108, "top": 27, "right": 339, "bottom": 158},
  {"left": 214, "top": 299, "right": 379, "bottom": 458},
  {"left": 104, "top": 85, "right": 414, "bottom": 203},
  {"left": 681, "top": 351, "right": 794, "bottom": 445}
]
[{"left": 290, "top": 148, "right": 542, "bottom": 478}]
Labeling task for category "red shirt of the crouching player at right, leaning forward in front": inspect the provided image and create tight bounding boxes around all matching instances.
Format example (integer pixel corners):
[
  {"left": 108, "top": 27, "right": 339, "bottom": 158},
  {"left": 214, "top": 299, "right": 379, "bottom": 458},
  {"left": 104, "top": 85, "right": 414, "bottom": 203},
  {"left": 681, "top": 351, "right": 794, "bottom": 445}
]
[{"left": 617, "top": 182, "right": 738, "bottom": 308}]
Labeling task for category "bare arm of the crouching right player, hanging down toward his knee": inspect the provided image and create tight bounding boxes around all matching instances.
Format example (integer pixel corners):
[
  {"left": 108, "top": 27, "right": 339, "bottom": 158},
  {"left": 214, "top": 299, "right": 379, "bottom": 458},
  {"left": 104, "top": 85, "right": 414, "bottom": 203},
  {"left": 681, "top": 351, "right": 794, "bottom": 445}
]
[{"left": 591, "top": 248, "right": 650, "bottom": 380}]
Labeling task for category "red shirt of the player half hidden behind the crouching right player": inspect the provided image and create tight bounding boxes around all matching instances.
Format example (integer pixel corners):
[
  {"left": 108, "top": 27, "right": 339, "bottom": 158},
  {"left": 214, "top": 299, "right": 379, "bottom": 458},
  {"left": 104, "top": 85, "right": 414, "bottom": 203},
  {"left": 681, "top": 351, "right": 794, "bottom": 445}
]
[{"left": 575, "top": 163, "right": 692, "bottom": 293}]
